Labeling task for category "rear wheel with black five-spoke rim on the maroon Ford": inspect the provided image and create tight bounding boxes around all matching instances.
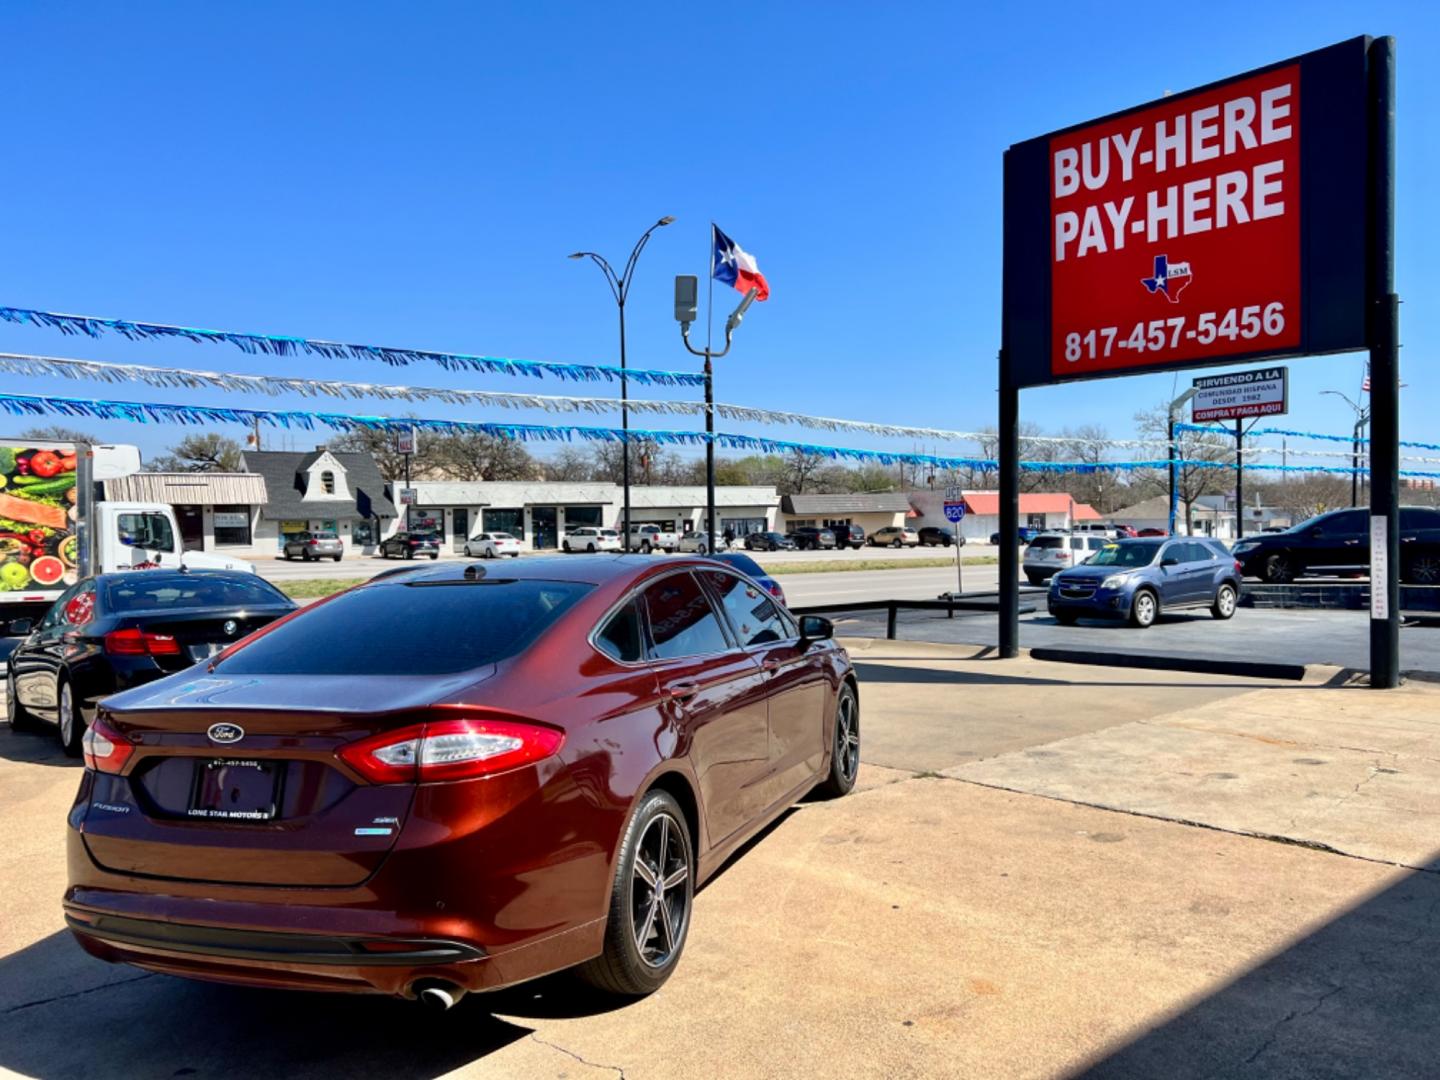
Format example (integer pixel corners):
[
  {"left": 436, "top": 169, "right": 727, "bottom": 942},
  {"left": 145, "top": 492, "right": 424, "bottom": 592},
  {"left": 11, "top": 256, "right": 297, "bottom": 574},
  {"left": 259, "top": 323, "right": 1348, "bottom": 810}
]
[{"left": 577, "top": 791, "right": 696, "bottom": 998}]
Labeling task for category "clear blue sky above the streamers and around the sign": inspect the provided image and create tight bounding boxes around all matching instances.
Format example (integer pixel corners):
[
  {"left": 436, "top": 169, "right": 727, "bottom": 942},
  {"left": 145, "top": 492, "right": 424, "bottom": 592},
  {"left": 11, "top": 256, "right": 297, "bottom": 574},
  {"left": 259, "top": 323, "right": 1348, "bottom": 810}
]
[{"left": 0, "top": 3, "right": 1440, "bottom": 469}]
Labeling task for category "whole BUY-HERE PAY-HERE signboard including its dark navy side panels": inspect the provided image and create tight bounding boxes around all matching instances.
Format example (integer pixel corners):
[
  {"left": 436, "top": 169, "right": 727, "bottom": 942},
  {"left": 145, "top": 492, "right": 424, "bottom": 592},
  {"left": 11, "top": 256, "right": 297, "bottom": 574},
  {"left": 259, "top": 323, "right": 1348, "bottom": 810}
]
[{"left": 1005, "top": 37, "right": 1368, "bottom": 386}]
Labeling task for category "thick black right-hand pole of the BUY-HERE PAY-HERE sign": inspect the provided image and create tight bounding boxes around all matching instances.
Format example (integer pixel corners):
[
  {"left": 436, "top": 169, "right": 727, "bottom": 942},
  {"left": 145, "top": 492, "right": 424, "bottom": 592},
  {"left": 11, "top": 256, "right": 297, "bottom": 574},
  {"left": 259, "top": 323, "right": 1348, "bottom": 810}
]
[{"left": 1367, "top": 37, "right": 1401, "bottom": 690}]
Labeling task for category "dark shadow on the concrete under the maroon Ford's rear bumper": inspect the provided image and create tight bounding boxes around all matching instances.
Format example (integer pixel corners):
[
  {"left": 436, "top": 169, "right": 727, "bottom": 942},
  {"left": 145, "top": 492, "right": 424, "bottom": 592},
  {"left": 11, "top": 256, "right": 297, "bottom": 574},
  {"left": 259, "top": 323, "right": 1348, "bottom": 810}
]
[{"left": 0, "top": 930, "right": 629, "bottom": 1080}]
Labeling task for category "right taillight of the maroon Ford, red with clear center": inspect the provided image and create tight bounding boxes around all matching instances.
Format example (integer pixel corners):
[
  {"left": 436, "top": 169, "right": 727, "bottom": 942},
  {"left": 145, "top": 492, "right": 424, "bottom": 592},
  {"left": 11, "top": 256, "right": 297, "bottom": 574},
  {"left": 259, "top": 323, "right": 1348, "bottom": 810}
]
[{"left": 337, "top": 719, "right": 564, "bottom": 783}]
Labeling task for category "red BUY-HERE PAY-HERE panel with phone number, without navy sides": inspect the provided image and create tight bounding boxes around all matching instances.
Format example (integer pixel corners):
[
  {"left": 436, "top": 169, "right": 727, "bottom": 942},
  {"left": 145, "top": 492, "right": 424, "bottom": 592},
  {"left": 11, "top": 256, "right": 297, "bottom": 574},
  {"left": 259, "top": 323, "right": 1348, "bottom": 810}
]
[{"left": 1050, "top": 65, "right": 1300, "bottom": 376}]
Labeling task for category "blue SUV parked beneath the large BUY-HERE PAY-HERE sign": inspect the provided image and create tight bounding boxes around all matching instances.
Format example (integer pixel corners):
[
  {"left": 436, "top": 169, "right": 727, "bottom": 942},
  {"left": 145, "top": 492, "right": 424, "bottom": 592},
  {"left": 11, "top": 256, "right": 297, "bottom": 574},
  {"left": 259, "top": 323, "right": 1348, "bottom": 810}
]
[{"left": 1048, "top": 536, "right": 1240, "bottom": 629}]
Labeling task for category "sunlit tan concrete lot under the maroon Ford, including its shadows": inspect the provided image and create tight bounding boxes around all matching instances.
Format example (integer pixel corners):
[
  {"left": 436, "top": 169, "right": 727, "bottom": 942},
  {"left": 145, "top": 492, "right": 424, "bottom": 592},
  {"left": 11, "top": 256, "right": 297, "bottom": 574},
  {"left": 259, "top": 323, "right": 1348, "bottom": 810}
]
[{"left": 0, "top": 639, "right": 1440, "bottom": 1079}]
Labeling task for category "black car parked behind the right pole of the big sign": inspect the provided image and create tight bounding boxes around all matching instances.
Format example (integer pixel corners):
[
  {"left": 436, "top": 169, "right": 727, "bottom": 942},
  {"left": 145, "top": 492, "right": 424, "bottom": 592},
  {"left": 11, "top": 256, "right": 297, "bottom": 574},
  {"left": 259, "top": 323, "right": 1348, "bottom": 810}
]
[{"left": 1231, "top": 507, "right": 1440, "bottom": 585}]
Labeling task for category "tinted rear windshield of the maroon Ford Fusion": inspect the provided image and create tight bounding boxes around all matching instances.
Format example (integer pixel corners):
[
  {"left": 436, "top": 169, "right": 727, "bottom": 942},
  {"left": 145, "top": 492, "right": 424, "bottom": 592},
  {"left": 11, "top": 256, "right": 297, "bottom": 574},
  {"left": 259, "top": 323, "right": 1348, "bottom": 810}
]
[{"left": 216, "top": 579, "right": 592, "bottom": 675}]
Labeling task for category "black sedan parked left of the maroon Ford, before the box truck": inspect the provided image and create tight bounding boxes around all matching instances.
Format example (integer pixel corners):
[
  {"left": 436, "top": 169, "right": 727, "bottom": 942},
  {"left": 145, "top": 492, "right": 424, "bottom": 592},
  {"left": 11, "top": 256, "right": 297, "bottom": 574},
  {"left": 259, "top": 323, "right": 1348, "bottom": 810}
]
[{"left": 6, "top": 570, "right": 298, "bottom": 757}]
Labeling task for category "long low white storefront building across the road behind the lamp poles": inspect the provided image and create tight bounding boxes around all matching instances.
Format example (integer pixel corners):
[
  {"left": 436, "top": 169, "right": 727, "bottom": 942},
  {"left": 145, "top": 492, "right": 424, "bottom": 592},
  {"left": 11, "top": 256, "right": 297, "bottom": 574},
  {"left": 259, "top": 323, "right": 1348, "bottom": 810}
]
[{"left": 392, "top": 481, "right": 779, "bottom": 552}]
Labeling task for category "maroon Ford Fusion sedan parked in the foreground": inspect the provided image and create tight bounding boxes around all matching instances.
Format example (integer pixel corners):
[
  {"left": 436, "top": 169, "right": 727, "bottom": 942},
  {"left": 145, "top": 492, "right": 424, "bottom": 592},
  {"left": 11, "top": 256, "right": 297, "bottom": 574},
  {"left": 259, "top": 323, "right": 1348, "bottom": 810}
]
[{"left": 65, "top": 556, "right": 860, "bottom": 1005}]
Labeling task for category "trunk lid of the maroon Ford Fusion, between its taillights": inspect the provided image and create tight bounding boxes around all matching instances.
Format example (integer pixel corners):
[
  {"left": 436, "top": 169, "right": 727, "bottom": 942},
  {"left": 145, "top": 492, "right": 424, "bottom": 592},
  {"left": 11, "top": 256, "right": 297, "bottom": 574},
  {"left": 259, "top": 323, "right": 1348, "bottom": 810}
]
[{"left": 81, "top": 668, "right": 489, "bottom": 887}]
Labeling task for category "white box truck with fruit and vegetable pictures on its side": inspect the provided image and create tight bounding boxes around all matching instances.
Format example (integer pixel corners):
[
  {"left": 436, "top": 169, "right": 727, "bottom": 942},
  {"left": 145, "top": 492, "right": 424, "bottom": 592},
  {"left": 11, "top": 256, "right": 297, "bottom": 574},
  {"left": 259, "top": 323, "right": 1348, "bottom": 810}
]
[{"left": 0, "top": 438, "right": 255, "bottom": 631}]
